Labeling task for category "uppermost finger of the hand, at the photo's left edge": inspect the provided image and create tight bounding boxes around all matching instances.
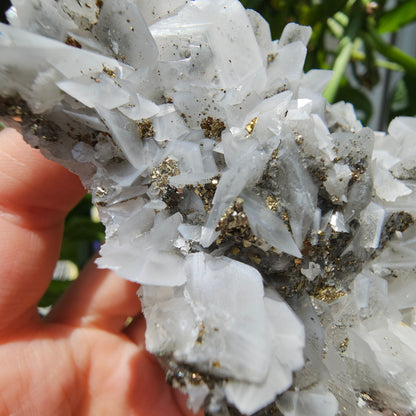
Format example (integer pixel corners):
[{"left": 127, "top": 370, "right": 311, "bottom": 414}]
[{"left": 0, "top": 129, "right": 85, "bottom": 334}]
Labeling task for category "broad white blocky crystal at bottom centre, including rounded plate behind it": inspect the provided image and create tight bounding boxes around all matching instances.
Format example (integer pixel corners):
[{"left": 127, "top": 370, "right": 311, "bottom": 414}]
[{"left": 140, "top": 253, "right": 305, "bottom": 414}]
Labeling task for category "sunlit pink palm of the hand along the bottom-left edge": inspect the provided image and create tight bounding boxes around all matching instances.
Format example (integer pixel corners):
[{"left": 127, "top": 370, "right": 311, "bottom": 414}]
[{"left": 0, "top": 325, "right": 188, "bottom": 416}]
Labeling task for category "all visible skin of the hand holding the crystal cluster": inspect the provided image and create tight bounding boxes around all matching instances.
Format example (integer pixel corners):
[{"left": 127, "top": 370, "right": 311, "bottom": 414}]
[{"left": 0, "top": 129, "right": 203, "bottom": 416}]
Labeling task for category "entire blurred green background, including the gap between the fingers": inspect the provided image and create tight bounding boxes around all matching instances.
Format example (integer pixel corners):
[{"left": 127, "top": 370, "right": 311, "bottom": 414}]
[{"left": 0, "top": 0, "right": 416, "bottom": 306}]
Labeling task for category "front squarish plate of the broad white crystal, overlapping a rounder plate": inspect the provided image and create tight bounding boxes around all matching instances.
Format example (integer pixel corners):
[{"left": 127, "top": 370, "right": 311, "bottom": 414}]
[{"left": 142, "top": 253, "right": 271, "bottom": 382}]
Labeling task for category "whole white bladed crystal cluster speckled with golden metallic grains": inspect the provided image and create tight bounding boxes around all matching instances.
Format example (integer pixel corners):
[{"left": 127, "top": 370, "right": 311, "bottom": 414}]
[{"left": 0, "top": 0, "right": 416, "bottom": 416}]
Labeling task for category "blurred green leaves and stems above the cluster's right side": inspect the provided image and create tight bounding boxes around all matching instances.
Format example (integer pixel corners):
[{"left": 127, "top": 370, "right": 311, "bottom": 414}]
[{"left": 241, "top": 0, "right": 416, "bottom": 124}]
